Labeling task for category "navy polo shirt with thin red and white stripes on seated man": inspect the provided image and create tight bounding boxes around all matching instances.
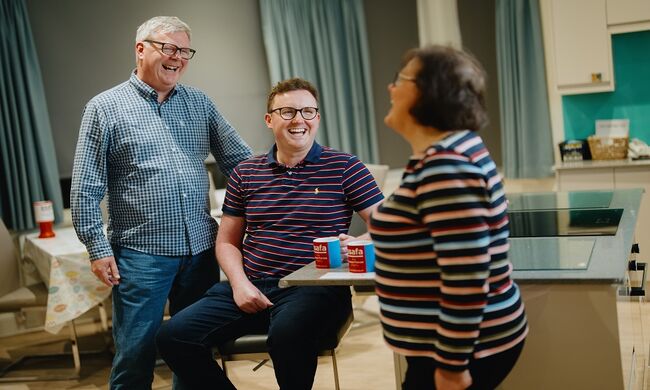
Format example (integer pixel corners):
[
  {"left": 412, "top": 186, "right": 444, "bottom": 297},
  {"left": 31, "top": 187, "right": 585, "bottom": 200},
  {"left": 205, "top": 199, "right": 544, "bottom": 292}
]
[{"left": 223, "top": 142, "right": 384, "bottom": 279}]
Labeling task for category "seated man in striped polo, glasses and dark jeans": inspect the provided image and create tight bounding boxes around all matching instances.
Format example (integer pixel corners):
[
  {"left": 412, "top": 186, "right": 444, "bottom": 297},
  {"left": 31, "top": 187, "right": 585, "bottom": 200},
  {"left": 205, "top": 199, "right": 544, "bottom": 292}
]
[{"left": 157, "top": 78, "right": 383, "bottom": 389}]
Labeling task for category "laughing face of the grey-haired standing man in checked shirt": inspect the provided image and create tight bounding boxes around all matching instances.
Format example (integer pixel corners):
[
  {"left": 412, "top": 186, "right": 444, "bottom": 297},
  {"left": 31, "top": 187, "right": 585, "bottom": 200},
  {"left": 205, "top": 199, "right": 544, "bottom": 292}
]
[{"left": 135, "top": 32, "right": 190, "bottom": 101}]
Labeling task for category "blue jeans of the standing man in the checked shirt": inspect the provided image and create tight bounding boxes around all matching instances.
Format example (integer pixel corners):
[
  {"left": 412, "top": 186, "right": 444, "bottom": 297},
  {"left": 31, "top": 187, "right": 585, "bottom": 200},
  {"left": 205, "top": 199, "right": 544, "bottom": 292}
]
[{"left": 110, "top": 247, "right": 219, "bottom": 390}]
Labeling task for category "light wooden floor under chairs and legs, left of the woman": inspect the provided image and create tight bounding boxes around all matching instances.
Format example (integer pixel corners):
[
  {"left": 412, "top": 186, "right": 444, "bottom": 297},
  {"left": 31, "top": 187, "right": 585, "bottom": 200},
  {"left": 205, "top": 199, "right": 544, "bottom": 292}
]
[{"left": 0, "top": 297, "right": 395, "bottom": 390}]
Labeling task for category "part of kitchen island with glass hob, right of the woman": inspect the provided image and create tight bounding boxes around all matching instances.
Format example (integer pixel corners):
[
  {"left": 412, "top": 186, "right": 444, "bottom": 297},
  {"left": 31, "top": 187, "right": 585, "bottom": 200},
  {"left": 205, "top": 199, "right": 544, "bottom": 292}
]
[{"left": 499, "top": 189, "right": 648, "bottom": 390}]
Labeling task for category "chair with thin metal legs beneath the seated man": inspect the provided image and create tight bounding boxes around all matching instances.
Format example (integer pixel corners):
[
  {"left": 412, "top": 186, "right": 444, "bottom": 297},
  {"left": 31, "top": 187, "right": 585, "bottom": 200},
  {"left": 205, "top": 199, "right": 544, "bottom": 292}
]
[{"left": 216, "top": 312, "right": 354, "bottom": 390}]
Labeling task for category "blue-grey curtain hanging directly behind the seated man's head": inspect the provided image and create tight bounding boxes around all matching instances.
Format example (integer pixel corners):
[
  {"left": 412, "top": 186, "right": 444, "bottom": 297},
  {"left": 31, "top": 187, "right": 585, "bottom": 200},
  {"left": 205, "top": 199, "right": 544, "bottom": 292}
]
[{"left": 260, "top": 0, "right": 379, "bottom": 163}]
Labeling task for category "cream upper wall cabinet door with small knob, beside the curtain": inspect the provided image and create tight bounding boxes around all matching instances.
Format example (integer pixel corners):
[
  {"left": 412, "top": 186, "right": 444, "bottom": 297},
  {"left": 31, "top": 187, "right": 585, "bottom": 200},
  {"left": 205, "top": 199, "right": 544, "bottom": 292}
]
[{"left": 550, "top": 0, "right": 614, "bottom": 94}]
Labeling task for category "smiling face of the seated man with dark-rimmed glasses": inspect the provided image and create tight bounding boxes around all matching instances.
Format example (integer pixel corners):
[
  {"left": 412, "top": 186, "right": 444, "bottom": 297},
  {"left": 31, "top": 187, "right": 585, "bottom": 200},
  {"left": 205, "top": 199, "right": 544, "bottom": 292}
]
[{"left": 264, "top": 89, "right": 320, "bottom": 160}]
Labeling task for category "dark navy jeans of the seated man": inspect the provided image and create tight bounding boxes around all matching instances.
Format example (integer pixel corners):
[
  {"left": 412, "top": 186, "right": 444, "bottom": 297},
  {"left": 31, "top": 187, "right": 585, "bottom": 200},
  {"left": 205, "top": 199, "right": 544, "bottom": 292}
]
[{"left": 156, "top": 279, "right": 352, "bottom": 390}]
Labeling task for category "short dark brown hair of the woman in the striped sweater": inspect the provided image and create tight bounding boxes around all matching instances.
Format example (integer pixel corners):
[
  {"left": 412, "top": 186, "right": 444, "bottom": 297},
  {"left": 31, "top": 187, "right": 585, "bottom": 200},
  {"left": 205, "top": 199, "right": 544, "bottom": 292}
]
[{"left": 404, "top": 45, "right": 488, "bottom": 131}]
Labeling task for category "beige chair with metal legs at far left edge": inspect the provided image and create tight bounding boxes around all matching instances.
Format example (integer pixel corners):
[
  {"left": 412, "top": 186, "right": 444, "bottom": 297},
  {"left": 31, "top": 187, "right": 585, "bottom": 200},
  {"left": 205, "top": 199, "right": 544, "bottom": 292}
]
[{"left": 0, "top": 219, "right": 81, "bottom": 383}]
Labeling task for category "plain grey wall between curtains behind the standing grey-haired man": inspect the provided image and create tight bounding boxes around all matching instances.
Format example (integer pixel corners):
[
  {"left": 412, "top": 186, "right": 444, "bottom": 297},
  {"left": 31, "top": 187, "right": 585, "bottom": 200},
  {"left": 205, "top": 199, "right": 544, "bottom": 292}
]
[{"left": 27, "top": 0, "right": 272, "bottom": 177}]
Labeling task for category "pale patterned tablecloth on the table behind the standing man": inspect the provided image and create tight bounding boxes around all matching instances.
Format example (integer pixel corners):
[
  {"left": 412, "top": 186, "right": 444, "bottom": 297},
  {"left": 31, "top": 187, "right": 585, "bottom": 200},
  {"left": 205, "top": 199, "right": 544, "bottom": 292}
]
[{"left": 23, "top": 228, "right": 111, "bottom": 333}]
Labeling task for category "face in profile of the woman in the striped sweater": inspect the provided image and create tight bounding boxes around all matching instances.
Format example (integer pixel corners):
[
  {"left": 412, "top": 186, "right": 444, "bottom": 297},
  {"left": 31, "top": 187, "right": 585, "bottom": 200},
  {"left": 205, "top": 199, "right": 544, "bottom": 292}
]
[{"left": 384, "top": 58, "right": 422, "bottom": 133}]
